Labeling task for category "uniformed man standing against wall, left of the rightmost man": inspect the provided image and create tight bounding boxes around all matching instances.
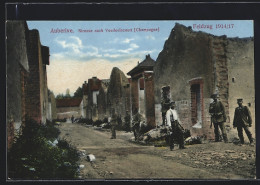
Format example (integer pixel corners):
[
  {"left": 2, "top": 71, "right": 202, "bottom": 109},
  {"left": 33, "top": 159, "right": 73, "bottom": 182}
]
[{"left": 209, "top": 94, "right": 228, "bottom": 143}]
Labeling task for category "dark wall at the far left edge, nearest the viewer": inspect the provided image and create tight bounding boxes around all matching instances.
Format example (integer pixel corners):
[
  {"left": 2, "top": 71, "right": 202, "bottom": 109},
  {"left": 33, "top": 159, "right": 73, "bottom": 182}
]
[{"left": 6, "top": 21, "right": 29, "bottom": 148}]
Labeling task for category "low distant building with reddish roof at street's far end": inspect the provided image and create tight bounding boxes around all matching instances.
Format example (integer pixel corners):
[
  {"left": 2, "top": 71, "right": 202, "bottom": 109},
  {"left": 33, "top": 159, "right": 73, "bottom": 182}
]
[{"left": 56, "top": 98, "right": 82, "bottom": 119}]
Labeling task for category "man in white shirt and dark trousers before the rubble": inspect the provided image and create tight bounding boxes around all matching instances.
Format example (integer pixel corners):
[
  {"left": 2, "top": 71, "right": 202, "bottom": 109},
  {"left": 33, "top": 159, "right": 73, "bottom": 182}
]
[{"left": 166, "top": 102, "right": 185, "bottom": 150}]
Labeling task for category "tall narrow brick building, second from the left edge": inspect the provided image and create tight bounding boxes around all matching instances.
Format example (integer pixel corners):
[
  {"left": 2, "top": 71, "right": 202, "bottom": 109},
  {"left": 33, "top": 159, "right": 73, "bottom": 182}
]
[{"left": 26, "top": 30, "right": 50, "bottom": 123}]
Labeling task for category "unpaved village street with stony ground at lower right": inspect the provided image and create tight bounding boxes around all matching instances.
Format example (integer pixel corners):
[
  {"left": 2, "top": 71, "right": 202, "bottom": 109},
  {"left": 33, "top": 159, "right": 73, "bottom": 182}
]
[{"left": 57, "top": 123, "right": 255, "bottom": 180}]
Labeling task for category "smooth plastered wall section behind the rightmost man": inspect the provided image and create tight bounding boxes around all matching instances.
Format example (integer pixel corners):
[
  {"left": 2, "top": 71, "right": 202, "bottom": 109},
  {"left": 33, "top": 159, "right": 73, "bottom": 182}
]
[{"left": 226, "top": 38, "right": 256, "bottom": 140}]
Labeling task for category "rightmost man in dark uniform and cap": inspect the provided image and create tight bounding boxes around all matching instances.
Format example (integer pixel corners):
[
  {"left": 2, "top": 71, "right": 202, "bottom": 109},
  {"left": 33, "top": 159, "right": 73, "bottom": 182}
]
[{"left": 233, "top": 99, "right": 253, "bottom": 144}]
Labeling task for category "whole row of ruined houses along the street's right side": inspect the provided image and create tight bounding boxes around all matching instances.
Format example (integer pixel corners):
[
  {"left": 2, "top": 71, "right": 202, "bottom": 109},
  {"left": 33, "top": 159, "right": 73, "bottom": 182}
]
[{"left": 54, "top": 24, "right": 255, "bottom": 139}]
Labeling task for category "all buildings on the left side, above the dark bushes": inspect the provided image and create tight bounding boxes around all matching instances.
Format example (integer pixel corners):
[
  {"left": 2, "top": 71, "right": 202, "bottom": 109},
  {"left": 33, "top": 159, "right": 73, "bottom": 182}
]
[{"left": 6, "top": 21, "right": 56, "bottom": 148}]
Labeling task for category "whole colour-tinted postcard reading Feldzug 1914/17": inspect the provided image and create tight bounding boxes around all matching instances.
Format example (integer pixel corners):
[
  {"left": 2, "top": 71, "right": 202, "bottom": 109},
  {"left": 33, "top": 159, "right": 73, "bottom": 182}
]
[{"left": 6, "top": 20, "right": 256, "bottom": 181}]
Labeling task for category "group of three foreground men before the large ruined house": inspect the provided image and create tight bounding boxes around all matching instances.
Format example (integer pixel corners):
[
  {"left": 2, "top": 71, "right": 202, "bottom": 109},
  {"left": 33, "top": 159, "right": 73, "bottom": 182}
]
[{"left": 162, "top": 94, "right": 253, "bottom": 150}]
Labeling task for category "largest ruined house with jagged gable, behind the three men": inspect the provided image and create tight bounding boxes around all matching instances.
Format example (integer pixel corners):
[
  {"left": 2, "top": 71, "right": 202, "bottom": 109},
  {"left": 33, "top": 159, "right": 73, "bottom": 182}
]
[{"left": 154, "top": 24, "right": 255, "bottom": 138}]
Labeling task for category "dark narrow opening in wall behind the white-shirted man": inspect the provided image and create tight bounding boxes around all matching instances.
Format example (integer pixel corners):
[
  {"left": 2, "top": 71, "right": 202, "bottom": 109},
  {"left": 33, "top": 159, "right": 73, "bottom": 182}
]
[{"left": 161, "top": 86, "right": 171, "bottom": 126}]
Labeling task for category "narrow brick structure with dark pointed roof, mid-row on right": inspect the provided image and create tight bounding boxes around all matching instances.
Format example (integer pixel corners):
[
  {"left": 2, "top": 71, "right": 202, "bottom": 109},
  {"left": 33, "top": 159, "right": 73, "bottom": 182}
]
[{"left": 127, "top": 55, "right": 156, "bottom": 128}]
